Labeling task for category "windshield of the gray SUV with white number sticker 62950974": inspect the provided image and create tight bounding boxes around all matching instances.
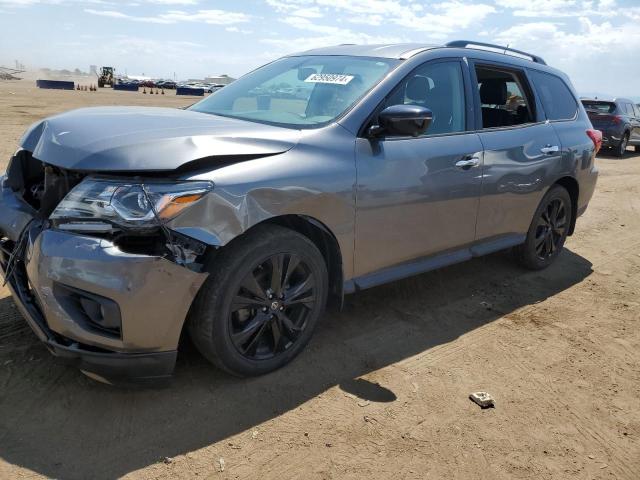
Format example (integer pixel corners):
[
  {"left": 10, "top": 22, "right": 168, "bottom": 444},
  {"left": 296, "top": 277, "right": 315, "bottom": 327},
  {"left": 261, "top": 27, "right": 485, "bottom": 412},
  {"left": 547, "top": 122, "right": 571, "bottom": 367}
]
[{"left": 189, "top": 56, "right": 399, "bottom": 128}]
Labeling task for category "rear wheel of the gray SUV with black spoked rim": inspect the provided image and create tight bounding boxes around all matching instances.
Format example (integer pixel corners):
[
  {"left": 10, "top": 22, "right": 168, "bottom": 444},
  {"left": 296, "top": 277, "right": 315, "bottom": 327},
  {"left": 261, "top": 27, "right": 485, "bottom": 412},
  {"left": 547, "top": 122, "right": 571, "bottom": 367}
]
[{"left": 514, "top": 185, "right": 573, "bottom": 270}]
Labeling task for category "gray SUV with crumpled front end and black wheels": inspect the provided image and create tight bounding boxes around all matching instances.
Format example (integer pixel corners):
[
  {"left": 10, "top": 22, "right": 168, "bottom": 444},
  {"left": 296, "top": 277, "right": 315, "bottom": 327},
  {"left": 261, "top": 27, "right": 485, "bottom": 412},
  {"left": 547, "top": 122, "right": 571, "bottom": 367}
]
[{"left": 0, "top": 41, "right": 601, "bottom": 383}]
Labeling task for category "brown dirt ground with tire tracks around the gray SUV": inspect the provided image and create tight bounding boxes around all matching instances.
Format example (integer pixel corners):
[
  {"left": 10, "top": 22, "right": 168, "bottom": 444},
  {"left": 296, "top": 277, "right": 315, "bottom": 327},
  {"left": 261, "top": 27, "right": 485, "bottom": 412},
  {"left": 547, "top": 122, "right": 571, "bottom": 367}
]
[{"left": 0, "top": 81, "right": 640, "bottom": 480}]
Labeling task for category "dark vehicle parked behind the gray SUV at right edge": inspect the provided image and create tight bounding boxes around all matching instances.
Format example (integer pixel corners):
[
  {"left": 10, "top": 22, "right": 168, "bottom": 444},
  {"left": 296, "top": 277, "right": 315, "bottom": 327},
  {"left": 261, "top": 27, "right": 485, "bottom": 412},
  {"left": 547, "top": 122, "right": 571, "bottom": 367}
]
[{"left": 582, "top": 98, "right": 640, "bottom": 157}]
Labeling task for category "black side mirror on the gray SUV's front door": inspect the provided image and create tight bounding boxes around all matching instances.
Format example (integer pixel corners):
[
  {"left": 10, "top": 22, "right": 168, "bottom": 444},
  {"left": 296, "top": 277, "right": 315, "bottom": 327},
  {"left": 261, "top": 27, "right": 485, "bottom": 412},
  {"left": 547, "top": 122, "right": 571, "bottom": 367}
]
[{"left": 369, "top": 105, "right": 433, "bottom": 137}]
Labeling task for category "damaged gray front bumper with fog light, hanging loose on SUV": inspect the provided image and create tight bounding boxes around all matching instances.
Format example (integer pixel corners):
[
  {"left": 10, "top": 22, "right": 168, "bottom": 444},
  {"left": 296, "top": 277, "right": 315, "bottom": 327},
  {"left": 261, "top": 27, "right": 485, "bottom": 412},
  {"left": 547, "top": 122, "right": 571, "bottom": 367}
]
[{"left": 0, "top": 181, "right": 207, "bottom": 384}]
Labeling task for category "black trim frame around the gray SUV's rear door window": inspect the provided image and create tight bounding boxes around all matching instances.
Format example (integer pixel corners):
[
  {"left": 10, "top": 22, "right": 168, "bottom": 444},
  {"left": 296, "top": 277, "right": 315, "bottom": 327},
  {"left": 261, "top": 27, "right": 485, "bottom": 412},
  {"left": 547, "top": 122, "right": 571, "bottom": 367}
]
[{"left": 469, "top": 59, "right": 547, "bottom": 133}]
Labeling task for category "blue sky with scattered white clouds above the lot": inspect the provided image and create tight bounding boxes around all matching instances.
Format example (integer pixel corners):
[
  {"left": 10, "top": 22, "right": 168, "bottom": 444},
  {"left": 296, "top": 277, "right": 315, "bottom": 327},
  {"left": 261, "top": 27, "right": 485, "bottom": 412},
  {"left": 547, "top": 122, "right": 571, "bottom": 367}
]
[{"left": 0, "top": 0, "right": 640, "bottom": 100}]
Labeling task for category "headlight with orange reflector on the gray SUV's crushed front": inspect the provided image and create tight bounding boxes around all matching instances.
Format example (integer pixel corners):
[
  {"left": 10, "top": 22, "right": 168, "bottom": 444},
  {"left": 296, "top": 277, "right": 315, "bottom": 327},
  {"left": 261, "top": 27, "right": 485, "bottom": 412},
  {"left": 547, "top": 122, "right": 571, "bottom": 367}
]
[{"left": 49, "top": 178, "right": 213, "bottom": 231}]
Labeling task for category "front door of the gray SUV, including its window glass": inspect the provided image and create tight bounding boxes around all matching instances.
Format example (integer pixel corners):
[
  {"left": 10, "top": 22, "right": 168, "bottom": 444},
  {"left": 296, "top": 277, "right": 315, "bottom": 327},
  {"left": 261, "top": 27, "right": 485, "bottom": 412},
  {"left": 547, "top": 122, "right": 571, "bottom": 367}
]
[{"left": 355, "top": 60, "right": 482, "bottom": 276}]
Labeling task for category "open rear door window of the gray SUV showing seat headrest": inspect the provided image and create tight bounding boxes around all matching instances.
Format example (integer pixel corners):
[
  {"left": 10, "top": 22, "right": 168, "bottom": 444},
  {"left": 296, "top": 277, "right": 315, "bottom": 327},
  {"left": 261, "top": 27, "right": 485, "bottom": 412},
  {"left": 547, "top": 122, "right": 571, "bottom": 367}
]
[{"left": 476, "top": 67, "right": 534, "bottom": 128}]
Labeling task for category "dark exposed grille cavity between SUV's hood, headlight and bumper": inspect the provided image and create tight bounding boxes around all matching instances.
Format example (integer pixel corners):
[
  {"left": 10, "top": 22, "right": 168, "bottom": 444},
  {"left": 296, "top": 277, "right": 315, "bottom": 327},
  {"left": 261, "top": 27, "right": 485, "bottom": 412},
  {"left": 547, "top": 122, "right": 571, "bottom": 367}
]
[{"left": 6, "top": 150, "right": 84, "bottom": 218}]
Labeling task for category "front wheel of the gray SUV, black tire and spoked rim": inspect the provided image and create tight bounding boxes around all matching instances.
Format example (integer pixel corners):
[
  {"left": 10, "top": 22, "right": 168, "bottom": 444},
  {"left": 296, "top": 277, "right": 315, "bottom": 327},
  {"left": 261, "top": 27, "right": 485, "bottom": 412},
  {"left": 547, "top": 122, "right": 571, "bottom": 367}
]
[{"left": 188, "top": 225, "right": 328, "bottom": 377}]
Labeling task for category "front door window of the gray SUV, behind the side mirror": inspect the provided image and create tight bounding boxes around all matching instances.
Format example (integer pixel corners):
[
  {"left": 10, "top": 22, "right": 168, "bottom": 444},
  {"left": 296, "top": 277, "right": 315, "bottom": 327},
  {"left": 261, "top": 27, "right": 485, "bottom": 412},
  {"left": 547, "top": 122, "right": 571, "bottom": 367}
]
[{"left": 384, "top": 61, "right": 465, "bottom": 135}]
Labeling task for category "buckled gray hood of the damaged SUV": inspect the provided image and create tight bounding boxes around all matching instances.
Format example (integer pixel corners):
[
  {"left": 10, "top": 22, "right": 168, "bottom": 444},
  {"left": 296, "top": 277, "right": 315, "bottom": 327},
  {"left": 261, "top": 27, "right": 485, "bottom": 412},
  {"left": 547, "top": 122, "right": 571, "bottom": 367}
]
[{"left": 20, "top": 107, "right": 300, "bottom": 172}]
